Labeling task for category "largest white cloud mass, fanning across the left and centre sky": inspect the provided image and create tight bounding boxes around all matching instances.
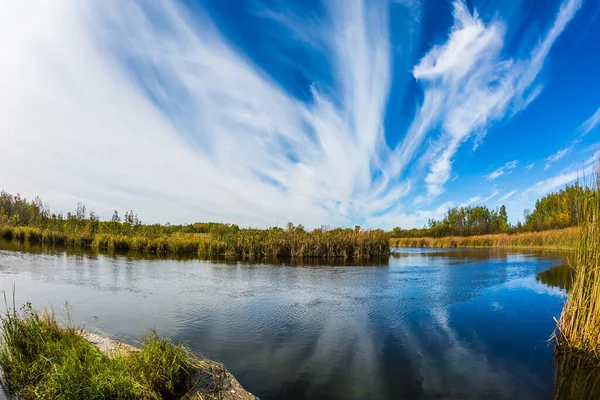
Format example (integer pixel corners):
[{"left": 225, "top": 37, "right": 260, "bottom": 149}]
[{"left": 0, "top": 1, "right": 409, "bottom": 226}]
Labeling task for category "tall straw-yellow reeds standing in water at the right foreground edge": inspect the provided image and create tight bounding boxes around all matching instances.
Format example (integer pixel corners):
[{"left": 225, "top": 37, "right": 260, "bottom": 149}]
[{"left": 556, "top": 178, "right": 600, "bottom": 360}]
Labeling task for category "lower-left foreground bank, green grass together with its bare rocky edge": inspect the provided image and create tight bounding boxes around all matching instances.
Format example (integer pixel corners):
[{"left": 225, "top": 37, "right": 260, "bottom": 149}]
[{"left": 0, "top": 304, "right": 258, "bottom": 400}]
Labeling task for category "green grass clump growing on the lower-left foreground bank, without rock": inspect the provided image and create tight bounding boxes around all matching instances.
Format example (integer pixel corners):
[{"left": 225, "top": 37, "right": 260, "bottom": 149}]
[{"left": 0, "top": 306, "right": 195, "bottom": 399}]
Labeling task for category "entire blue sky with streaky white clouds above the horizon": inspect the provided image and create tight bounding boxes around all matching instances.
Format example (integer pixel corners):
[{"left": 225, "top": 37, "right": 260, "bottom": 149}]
[{"left": 0, "top": 0, "right": 600, "bottom": 229}]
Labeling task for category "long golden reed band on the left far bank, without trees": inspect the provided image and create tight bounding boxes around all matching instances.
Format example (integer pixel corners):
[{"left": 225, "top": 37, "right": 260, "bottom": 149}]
[{"left": 0, "top": 226, "right": 390, "bottom": 259}]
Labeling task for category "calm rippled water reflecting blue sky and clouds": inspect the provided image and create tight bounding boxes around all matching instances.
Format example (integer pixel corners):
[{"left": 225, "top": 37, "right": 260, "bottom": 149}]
[{"left": 0, "top": 244, "right": 566, "bottom": 399}]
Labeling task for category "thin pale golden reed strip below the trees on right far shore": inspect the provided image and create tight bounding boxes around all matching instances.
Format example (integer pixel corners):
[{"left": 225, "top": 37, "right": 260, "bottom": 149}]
[{"left": 390, "top": 228, "right": 579, "bottom": 250}]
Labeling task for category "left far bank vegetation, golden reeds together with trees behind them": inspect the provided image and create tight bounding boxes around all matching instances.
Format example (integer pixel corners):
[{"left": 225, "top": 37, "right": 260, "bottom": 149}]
[{"left": 0, "top": 192, "right": 390, "bottom": 259}]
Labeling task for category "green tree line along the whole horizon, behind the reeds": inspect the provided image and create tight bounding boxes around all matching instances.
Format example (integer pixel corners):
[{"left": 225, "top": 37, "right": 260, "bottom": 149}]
[{"left": 0, "top": 183, "right": 594, "bottom": 244}]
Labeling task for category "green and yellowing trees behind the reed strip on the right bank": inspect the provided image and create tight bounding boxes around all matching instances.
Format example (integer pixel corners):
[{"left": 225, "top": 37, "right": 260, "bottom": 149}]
[{"left": 391, "top": 184, "right": 593, "bottom": 238}]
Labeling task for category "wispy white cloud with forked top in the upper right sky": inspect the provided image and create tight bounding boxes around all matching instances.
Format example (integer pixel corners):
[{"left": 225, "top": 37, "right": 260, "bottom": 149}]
[{"left": 409, "top": 0, "right": 581, "bottom": 196}]
